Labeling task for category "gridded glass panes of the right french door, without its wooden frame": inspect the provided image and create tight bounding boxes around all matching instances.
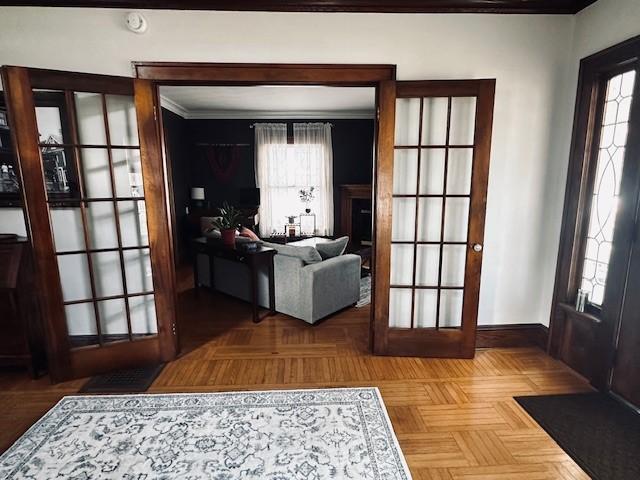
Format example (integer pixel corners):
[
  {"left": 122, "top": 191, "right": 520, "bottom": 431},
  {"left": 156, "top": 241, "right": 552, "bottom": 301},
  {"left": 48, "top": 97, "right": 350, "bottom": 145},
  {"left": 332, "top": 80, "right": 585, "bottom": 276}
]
[{"left": 389, "top": 97, "right": 476, "bottom": 329}]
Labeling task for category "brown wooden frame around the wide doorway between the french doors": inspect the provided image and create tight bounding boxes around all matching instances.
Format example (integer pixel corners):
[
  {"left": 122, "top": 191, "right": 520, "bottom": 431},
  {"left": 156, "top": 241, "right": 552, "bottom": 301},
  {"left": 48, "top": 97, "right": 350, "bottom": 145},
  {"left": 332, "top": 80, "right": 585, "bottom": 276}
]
[{"left": 133, "top": 62, "right": 396, "bottom": 347}]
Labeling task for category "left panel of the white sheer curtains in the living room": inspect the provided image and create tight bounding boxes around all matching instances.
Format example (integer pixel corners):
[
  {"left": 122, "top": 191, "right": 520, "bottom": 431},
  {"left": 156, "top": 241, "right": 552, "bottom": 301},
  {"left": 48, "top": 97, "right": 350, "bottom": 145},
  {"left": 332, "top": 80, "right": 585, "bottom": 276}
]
[{"left": 254, "top": 123, "right": 287, "bottom": 237}]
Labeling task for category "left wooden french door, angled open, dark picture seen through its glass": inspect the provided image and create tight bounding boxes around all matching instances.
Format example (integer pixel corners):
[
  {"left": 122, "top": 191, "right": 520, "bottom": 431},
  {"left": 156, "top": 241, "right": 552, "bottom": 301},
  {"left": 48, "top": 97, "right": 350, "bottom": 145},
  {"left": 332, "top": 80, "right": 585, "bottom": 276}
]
[{"left": 2, "top": 67, "right": 177, "bottom": 381}]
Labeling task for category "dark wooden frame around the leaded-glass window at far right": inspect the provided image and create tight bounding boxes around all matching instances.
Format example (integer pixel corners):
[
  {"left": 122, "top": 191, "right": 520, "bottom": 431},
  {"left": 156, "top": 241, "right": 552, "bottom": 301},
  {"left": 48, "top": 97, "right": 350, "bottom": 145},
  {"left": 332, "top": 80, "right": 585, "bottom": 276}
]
[{"left": 547, "top": 36, "right": 640, "bottom": 390}]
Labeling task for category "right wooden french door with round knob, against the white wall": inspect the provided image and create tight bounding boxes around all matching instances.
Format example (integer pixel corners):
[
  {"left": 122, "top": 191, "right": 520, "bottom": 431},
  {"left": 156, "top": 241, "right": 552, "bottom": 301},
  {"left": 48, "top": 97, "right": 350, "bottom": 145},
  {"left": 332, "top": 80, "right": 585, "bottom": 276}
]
[{"left": 373, "top": 80, "right": 495, "bottom": 358}]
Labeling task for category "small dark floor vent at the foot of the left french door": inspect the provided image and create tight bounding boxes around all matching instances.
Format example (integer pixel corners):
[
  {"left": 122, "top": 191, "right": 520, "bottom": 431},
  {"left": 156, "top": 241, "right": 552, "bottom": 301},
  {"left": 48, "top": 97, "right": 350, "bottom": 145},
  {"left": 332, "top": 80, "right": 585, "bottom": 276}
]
[{"left": 80, "top": 363, "right": 164, "bottom": 393}]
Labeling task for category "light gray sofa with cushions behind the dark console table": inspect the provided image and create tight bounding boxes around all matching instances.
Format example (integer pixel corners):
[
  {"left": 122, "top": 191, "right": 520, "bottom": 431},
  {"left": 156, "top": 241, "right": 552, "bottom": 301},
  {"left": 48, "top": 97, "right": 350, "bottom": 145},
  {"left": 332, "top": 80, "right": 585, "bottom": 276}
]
[{"left": 192, "top": 232, "right": 360, "bottom": 324}]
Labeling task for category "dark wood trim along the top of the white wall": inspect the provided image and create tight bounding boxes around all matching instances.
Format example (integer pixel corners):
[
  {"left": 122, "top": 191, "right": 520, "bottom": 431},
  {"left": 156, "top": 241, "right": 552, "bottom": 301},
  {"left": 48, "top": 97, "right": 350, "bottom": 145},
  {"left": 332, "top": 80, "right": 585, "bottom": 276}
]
[{"left": 0, "top": 0, "right": 596, "bottom": 14}]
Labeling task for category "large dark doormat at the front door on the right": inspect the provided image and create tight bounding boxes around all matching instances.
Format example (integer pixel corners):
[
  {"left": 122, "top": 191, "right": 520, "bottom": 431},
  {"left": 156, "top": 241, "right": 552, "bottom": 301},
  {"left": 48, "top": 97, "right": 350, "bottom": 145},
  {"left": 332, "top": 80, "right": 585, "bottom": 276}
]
[{"left": 515, "top": 393, "right": 640, "bottom": 480}]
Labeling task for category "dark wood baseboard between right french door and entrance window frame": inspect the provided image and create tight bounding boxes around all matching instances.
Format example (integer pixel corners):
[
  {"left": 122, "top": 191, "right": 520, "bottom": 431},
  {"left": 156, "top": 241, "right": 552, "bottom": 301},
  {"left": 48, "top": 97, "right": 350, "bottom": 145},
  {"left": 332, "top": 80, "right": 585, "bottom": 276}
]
[{"left": 476, "top": 323, "right": 549, "bottom": 350}]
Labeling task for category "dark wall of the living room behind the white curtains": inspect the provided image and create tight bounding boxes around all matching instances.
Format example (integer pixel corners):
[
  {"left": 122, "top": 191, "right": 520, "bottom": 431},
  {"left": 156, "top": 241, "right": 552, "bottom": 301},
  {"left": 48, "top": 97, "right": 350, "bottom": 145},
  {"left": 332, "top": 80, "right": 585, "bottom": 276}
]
[{"left": 163, "top": 109, "right": 375, "bottom": 262}]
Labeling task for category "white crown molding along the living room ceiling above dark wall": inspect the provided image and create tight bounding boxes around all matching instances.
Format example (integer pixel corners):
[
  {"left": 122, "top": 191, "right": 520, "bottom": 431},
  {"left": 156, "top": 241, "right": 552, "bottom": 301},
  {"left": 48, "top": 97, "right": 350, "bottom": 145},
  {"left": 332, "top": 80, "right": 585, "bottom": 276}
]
[{"left": 160, "top": 95, "right": 375, "bottom": 120}]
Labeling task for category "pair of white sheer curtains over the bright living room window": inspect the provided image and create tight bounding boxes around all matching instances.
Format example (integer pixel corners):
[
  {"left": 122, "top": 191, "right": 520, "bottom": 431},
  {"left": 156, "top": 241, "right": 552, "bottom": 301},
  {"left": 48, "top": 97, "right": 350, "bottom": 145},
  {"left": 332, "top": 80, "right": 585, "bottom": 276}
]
[{"left": 255, "top": 123, "right": 333, "bottom": 237}]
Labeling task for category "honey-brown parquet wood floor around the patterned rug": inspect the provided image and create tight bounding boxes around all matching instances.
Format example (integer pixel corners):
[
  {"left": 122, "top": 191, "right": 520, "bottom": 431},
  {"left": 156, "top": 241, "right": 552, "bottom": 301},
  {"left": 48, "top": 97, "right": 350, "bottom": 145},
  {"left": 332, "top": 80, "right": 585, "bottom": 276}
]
[{"left": 0, "top": 291, "right": 590, "bottom": 480}]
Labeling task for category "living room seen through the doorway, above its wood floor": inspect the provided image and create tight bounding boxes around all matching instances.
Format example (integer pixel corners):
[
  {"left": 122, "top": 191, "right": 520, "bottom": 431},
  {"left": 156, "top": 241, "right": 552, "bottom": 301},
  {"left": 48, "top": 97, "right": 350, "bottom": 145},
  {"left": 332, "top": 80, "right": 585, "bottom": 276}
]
[{"left": 159, "top": 85, "right": 376, "bottom": 338}]
